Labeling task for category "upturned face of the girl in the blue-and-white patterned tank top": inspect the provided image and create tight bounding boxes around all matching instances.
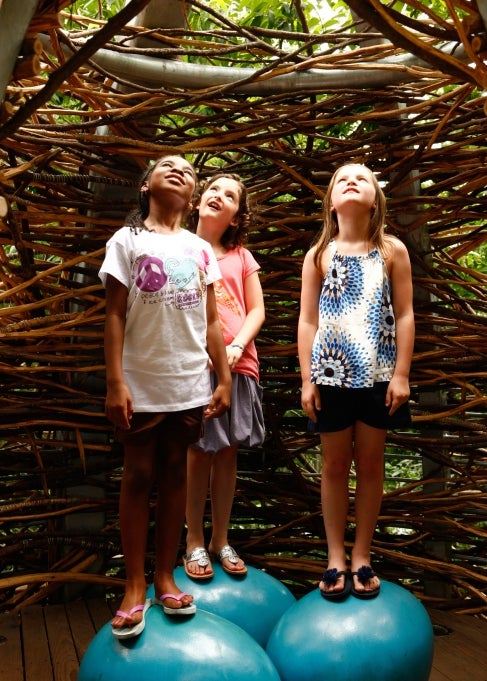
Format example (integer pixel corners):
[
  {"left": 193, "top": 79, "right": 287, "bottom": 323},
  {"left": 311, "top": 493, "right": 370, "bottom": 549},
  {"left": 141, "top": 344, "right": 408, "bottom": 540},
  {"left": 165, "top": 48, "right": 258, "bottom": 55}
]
[{"left": 331, "top": 164, "right": 376, "bottom": 212}]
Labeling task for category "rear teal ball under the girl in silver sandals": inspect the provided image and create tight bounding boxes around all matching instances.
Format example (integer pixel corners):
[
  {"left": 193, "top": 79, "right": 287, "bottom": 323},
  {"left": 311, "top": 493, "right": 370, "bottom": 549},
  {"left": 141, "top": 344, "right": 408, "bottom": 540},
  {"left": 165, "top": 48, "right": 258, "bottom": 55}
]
[{"left": 147, "top": 561, "right": 296, "bottom": 648}]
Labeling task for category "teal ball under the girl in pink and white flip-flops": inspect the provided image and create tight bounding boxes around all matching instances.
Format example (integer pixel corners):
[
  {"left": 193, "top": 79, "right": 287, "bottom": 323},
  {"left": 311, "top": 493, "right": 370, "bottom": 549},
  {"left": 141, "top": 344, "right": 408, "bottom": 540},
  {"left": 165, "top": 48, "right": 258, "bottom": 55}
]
[{"left": 78, "top": 605, "right": 280, "bottom": 681}]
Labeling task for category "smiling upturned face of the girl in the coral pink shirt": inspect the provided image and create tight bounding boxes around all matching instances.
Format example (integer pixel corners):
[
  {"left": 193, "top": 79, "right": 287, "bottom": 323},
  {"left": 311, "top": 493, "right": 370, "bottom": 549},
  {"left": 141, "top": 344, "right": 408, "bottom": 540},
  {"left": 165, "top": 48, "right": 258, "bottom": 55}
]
[{"left": 198, "top": 177, "right": 241, "bottom": 234}]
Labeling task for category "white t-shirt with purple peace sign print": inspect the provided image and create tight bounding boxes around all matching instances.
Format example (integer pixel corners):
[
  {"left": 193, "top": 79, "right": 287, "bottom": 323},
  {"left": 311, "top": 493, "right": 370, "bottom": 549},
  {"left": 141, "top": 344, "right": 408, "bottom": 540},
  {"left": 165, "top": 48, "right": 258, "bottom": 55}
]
[{"left": 99, "top": 227, "right": 221, "bottom": 412}]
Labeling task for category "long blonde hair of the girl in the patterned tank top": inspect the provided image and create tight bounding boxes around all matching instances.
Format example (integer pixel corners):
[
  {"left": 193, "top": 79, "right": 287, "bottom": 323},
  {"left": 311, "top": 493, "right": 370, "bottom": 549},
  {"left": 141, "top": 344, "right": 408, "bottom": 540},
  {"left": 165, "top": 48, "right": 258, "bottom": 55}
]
[{"left": 313, "top": 163, "right": 386, "bottom": 268}]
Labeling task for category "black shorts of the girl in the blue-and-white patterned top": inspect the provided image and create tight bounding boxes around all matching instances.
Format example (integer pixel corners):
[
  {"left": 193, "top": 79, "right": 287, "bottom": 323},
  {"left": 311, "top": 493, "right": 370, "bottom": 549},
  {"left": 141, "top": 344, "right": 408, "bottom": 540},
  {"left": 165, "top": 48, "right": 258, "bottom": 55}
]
[{"left": 309, "top": 382, "right": 411, "bottom": 433}]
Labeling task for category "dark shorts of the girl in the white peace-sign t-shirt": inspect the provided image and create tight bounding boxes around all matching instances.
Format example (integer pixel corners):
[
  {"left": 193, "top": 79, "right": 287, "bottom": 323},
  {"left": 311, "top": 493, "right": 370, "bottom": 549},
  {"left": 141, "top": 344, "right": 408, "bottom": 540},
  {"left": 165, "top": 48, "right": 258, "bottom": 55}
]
[{"left": 115, "top": 407, "right": 203, "bottom": 448}]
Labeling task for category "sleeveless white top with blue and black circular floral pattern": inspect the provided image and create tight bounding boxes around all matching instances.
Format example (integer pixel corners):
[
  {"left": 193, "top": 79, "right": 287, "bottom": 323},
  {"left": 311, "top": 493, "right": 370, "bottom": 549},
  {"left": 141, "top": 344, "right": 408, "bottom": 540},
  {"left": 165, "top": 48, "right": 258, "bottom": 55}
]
[{"left": 311, "top": 241, "right": 396, "bottom": 388}]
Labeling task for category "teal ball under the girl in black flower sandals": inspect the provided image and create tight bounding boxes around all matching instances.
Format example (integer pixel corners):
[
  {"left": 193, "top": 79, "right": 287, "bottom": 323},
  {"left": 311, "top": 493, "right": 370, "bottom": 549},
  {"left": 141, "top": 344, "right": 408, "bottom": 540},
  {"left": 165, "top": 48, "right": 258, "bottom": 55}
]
[{"left": 266, "top": 580, "right": 433, "bottom": 681}]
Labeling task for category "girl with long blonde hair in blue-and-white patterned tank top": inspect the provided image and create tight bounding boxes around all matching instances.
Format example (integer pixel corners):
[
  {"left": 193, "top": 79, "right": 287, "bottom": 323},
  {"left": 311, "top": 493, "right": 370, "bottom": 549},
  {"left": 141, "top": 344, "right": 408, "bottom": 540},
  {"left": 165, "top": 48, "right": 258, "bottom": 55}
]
[{"left": 298, "top": 164, "right": 414, "bottom": 600}]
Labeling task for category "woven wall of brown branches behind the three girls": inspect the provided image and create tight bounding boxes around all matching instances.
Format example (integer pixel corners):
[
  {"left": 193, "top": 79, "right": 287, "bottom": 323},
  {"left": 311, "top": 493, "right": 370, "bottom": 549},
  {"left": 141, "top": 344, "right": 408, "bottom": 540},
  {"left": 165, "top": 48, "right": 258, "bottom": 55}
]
[{"left": 0, "top": 0, "right": 487, "bottom": 614}]
